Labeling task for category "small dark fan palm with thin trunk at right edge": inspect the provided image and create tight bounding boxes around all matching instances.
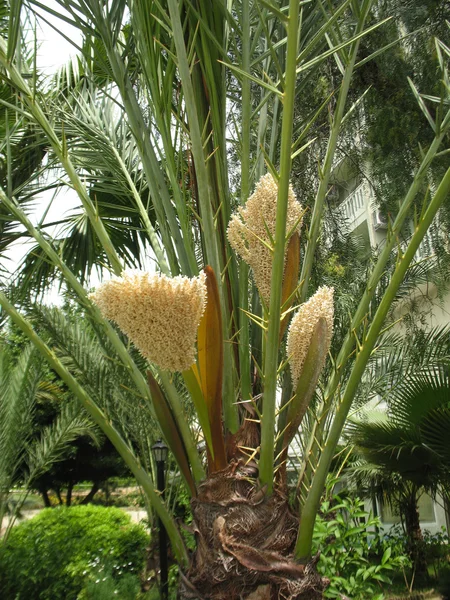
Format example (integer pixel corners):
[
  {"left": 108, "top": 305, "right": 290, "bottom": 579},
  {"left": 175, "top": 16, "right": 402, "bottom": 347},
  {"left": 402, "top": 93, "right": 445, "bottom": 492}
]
[{"left": 350, "top": 362, "right": 450, "bottom": 574}]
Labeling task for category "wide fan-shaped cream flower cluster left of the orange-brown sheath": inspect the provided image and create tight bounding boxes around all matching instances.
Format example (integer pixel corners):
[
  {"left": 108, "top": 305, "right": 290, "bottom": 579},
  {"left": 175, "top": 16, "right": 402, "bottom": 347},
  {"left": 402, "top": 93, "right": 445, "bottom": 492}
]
[{"left": 90, "top": 271, "right": 206, "bottom": 371}]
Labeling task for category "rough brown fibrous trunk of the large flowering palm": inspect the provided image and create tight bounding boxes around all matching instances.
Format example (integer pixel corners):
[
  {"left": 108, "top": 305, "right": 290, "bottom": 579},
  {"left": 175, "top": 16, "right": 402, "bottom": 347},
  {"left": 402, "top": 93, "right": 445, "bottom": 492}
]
[{"left": 181, "top": 462, "right": 328, "bottom": 600}]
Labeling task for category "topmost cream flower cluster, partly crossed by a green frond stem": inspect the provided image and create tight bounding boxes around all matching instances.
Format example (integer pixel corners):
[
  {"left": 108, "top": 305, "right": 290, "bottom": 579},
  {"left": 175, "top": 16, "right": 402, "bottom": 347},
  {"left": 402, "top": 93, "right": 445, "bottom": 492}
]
[{"left": 227, "top": 173, "right": 303, "bottom": 304}]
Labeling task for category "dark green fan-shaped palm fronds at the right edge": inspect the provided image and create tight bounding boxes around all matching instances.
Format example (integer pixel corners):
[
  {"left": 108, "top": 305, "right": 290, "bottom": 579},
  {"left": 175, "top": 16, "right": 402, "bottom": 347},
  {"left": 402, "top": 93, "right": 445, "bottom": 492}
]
[{"left": 347, "top": 367, "right": 450, "bottom": 496}]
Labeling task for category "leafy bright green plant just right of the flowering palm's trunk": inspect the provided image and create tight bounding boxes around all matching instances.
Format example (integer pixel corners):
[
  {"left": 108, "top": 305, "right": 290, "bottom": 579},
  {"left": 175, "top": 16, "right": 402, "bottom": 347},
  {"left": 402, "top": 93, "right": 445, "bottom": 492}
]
[{"left": 314, "top": 496, "right": 408, "bottom": 600}]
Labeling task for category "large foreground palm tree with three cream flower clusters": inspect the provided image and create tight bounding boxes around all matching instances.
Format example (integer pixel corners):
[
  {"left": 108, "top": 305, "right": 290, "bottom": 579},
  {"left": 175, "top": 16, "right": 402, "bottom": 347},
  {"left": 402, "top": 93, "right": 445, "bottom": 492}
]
[{"left": 0, "top": 0, "right": 450, "bottom": 599}]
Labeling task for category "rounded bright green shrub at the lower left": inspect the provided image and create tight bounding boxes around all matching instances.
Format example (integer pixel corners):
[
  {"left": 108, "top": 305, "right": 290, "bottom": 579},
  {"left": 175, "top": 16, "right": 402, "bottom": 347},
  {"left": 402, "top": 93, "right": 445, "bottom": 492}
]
[{"left": 0, "top": 506, "right": 148, "bottom": 600}]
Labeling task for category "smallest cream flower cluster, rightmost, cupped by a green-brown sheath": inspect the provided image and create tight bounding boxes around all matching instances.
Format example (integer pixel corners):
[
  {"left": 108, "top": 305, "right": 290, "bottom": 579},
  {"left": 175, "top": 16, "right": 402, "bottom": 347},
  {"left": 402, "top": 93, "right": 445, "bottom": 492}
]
[{"left": 287, "top": 286, "right": 334, "bottom": 385}]
